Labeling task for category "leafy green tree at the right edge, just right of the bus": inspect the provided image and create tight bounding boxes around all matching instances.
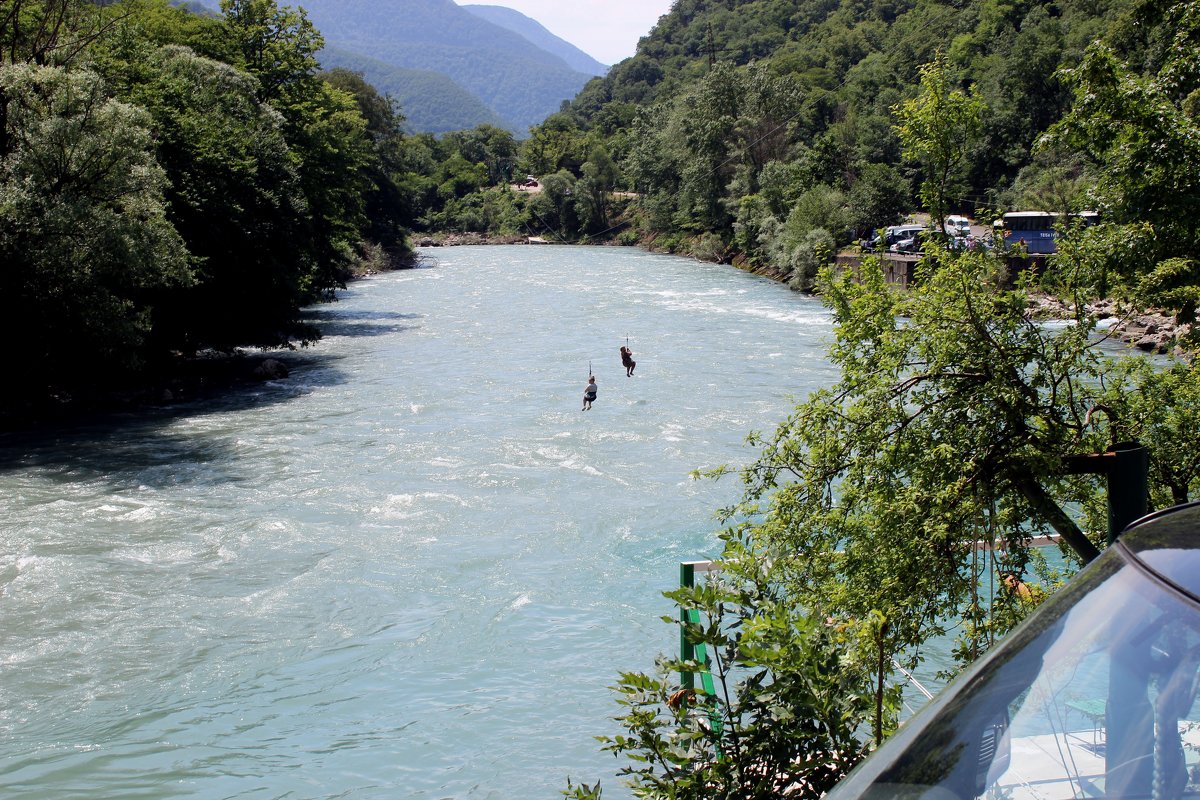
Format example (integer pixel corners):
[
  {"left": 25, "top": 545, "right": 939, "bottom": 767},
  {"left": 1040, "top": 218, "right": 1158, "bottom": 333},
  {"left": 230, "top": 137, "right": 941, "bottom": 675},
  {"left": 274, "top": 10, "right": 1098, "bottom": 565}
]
[{"left": 1043, "top": 4, "right": 1200, "bottom": 320}]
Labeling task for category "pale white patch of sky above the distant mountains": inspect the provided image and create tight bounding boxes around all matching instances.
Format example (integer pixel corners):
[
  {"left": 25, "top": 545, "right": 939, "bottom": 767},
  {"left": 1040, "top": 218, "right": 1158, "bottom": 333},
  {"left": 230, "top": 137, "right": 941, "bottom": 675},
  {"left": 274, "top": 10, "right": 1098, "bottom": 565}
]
[{"left": 457, "top": 0, "right": 672, "bottom": 65}]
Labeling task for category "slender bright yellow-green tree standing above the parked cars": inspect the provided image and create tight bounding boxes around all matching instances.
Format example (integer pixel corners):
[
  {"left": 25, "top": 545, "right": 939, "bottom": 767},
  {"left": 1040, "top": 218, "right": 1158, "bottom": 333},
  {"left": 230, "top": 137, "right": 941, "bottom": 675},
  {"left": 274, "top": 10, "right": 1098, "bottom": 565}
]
[{"left": 893, "top": 54, "right": 984, "bottom": 230}]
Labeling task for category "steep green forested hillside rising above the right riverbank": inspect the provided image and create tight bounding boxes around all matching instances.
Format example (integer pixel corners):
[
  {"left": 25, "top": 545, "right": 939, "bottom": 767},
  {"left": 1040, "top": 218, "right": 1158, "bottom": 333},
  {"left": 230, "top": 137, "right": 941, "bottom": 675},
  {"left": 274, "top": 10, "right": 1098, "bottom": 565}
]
[{"left": 499, "top": 0, "right": 1162, "bottom": 280}]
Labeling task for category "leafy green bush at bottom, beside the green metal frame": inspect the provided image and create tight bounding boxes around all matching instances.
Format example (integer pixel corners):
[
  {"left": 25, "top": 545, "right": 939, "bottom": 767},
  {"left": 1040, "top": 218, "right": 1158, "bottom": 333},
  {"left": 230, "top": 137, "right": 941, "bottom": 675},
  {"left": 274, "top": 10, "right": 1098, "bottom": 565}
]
[{"left": 569, "top": 533, "right": 899, "bottom": 800}]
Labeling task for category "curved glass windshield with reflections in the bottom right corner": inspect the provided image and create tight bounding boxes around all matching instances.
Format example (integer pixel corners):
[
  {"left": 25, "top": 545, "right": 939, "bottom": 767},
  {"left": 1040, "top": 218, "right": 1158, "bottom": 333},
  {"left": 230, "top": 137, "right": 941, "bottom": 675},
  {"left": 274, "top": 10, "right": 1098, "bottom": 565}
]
[{"left": 830, "top": 509, "right": 1200, "bottom": 800}]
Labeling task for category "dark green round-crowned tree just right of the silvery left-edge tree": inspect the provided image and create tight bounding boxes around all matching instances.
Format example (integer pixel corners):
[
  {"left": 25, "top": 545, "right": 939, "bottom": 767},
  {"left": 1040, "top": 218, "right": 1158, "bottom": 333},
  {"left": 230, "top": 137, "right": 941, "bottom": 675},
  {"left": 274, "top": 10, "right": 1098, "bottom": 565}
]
[{"left": 108, "top": 46, "right": 312, "bottom": 353}]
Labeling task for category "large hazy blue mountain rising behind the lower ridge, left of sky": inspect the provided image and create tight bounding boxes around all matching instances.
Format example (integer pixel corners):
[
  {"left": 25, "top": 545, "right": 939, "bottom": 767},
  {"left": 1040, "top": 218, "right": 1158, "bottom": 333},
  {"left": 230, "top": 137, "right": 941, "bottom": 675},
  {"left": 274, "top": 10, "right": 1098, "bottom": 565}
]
[{"left": 301, "top": 0, "right": 592, "bottom": 132}]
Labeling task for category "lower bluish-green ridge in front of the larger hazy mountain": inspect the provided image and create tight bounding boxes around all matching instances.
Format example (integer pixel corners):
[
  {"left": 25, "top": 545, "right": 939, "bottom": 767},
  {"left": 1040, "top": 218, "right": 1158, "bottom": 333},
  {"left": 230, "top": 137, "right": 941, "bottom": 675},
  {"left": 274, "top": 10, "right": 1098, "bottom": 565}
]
[{"left": 319, "top": 47, "right": 513, "bottom": 133}]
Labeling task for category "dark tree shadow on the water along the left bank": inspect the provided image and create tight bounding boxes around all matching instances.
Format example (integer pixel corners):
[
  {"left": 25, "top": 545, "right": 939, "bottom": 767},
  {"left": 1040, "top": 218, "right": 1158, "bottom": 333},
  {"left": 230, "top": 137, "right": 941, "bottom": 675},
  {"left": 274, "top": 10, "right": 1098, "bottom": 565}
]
[{"left": 0, "top": 351, "right": 349, "bottom": 485}]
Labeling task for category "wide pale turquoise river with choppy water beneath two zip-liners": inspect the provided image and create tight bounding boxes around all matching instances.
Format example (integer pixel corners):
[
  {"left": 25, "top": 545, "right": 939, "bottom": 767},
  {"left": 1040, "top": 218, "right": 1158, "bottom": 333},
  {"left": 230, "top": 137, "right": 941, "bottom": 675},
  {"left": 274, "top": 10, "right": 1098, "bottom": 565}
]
[{"left": 0, "top": 246, "right": 834, "bottom": 800}]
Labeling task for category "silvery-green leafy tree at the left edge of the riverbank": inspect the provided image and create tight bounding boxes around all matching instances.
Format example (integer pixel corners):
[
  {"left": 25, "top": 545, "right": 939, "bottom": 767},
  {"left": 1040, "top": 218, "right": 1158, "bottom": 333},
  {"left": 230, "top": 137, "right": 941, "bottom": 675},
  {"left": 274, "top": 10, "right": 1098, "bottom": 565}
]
[{"left": 0, "top": 65, "right": 193, "bottom": 397}]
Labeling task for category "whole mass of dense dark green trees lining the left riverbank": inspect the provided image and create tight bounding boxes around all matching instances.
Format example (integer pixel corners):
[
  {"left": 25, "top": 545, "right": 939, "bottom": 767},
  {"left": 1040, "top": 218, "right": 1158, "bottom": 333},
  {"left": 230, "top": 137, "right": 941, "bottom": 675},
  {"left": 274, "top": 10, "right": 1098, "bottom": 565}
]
[{"left": 0, "top": 0, "right": 422, "bottom": 417}]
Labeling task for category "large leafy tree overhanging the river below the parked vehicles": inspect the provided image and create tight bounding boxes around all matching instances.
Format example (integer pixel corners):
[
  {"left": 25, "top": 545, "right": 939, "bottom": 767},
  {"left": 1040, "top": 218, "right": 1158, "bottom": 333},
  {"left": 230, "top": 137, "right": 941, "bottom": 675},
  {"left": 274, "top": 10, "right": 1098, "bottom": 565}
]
[{"left": 705, "top": 253, "right": 1104, "bottom": 671}]
